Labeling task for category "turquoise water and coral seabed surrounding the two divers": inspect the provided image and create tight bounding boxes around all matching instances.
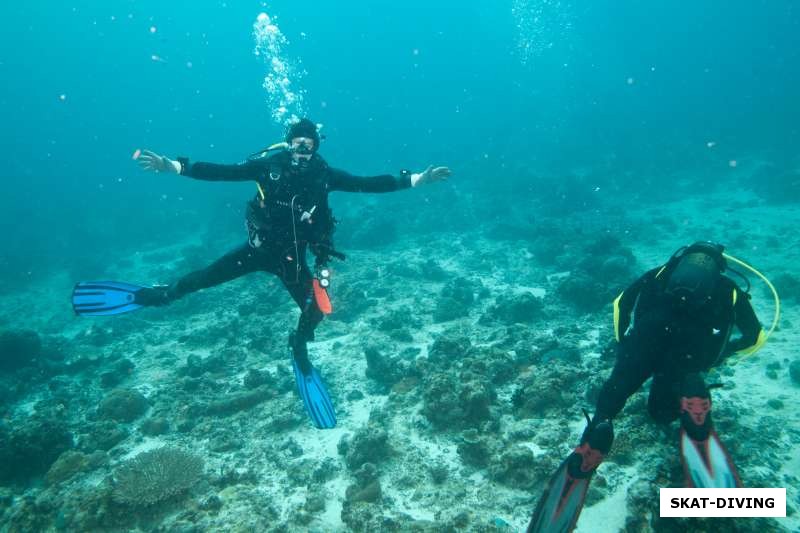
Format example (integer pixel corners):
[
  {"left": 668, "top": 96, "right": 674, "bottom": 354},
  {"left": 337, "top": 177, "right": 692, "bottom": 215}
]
[{"left": 0, "top": 0, "right": 800, "bottom": 532}]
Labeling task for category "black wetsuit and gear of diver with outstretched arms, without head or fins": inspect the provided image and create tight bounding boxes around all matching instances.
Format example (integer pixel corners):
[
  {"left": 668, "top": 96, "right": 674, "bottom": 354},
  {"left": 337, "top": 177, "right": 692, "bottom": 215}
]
[{"left": 167, "top": 152, "right": 411, "bottom": 362}]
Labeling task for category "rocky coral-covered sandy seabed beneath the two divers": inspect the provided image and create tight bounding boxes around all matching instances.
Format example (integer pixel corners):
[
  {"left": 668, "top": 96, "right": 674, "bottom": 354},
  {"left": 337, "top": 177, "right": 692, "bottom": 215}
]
[{"left": 0, "top": 171, "right": 800, "bottom": 533}]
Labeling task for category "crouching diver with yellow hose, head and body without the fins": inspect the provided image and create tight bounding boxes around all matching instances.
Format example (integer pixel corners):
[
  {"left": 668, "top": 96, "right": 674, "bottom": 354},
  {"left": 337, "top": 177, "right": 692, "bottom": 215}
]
[{"left": 581, "top": 242, "right": 763, "bottom": 474}]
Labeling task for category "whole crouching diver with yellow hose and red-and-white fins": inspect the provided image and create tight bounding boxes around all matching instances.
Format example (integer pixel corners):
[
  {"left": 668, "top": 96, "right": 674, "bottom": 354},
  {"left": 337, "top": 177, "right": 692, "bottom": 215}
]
[{"left": 528, "top": 242, "right": 779, "bottom": 533}]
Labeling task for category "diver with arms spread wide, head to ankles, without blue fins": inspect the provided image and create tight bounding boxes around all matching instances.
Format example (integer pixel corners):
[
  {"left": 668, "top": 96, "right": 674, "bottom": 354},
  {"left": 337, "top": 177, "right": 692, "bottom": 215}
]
[{"left": 136, "top": 119, "right": 450, "bottom": 374}]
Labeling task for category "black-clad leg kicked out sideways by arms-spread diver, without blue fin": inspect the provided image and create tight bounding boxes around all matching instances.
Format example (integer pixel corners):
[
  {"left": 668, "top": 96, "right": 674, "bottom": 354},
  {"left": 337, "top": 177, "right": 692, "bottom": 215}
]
[{"left": 136, "top": 245, "right": 262, "bottom": 305}]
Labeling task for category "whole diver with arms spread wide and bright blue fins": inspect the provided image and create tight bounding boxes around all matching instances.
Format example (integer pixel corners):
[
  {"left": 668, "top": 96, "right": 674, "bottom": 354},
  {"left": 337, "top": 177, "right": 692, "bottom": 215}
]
[{"left": 72, "top": 118, "right": 450, "bottom": 429}]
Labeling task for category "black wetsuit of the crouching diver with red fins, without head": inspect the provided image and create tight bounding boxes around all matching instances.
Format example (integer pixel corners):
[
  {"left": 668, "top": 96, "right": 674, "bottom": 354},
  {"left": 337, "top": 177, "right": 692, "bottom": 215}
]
[{"left": 595, "top": 268, "right": 761, "bottom": 422}]
